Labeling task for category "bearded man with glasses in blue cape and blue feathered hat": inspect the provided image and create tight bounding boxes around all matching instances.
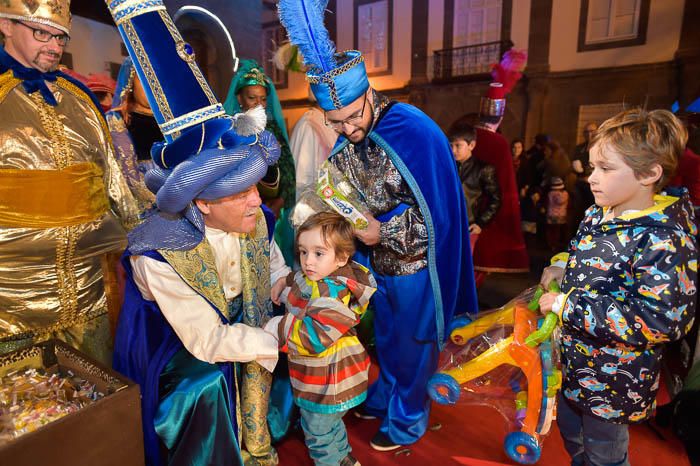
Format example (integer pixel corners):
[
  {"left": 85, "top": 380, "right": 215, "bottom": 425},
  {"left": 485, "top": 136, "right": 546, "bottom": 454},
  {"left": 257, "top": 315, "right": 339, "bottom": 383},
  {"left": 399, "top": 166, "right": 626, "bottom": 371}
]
[{"left": 279, "top": 0, "right": 477, "bottom": 451}]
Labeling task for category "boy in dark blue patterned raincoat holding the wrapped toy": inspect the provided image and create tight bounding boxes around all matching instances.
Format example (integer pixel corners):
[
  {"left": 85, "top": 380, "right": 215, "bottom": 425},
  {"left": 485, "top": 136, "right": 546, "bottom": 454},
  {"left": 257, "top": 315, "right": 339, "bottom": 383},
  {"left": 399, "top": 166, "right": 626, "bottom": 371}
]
[{"left": 540, "top": 109, "right": 697, "bottom": 465}]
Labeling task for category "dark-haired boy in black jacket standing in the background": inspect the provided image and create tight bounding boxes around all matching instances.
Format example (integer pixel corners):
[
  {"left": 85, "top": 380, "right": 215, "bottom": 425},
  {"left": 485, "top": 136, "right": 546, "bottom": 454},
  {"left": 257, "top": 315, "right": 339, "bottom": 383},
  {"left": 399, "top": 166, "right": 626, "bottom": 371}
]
[{"left": 447, "top": 125, "right": 501, "bottom": 238}]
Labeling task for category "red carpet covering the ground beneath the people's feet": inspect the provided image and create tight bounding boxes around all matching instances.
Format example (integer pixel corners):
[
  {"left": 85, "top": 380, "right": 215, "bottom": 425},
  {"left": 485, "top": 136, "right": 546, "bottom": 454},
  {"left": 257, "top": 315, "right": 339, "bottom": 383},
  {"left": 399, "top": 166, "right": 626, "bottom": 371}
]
[{"left": 277, "top": 364, "right": 690, "bottom": 466}]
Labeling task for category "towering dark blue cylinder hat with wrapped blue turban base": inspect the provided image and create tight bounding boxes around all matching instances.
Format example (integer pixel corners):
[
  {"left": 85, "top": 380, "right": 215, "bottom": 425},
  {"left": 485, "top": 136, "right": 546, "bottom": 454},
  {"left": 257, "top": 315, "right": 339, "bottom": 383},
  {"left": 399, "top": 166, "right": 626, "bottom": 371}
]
[{"left": 106, "top": 0, "right": 279, "bottom": 253}]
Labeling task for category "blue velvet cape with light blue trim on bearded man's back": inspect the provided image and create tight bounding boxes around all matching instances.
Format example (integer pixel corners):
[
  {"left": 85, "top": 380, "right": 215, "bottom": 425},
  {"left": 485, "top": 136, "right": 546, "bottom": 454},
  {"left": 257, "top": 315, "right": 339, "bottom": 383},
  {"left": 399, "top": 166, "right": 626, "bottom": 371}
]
[{"left": 331, "top": 103, "right": 478, "bottom": 346}]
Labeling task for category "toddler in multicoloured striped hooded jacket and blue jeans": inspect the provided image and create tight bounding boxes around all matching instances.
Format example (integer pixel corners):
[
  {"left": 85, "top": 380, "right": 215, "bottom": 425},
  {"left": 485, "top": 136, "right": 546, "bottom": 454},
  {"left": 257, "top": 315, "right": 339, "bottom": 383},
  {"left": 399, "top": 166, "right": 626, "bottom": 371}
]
[{"left": 265, "top": 212, "right": 377, "bottom": 466}]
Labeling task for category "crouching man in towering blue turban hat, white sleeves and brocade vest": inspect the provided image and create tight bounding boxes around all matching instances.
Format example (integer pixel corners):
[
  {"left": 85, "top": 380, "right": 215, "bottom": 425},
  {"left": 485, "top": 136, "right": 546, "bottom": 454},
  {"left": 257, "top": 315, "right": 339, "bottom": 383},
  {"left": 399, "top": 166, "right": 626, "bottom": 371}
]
[{"left": 102, "top": 0, "right": 289, "bottom": 466}]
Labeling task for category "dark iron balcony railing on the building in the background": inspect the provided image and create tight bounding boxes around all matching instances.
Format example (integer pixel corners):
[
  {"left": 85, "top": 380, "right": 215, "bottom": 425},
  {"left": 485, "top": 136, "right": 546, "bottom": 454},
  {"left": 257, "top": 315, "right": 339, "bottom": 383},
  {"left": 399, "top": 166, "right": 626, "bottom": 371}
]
[{"left": 433, "top": 40, "right": 513, "bottom": 80}]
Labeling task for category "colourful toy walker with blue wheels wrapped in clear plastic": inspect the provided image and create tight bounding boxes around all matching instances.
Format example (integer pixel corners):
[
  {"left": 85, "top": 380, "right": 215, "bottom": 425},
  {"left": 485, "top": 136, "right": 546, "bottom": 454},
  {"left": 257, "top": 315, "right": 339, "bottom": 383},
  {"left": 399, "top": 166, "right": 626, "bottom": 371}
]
[{"left": 428, "top": 285, "right": 561, "bottom": 464}]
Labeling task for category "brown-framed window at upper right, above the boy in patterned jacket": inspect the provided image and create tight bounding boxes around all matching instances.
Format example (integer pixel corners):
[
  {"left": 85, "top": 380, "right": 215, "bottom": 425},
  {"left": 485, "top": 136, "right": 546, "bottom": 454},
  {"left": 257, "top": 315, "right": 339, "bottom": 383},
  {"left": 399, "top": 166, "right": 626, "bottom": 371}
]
[{"left": 578, "top": 0, "right": 650, "bottom": 52}]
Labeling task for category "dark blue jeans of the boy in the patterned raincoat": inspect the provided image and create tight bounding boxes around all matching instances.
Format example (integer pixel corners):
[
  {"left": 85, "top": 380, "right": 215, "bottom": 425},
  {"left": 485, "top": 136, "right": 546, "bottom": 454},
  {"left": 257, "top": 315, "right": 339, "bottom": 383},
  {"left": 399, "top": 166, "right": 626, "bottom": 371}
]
[{"left": 557, "top": 394, "right": 630, "bottom": 466}]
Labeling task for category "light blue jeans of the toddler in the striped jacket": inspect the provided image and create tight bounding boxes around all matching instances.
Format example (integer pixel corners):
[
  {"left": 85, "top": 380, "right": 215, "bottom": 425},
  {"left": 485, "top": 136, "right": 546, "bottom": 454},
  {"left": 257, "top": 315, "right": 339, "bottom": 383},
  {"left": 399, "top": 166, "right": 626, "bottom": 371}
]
[{"left": 299, "top": 408, "right": 350, "bottom": 466}]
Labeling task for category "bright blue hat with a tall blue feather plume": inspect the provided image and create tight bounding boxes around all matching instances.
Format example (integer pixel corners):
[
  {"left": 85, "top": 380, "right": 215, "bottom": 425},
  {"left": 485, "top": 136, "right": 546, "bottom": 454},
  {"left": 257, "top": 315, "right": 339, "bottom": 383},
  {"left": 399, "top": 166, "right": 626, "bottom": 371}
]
[{"left": 278, "top": 0, "right": 369, "bottom": 111}]
